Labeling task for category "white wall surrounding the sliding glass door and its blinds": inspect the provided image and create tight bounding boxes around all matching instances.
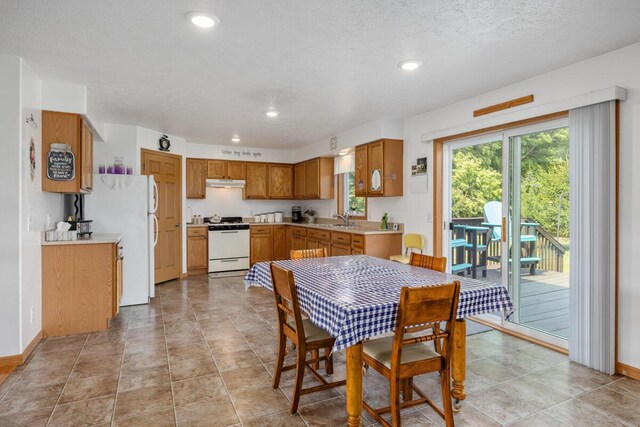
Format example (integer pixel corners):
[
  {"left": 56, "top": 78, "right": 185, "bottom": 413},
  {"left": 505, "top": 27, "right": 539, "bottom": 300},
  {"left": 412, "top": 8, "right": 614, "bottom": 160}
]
[{"left": 400, "top": 44, "right": 640, "bottom": 367}]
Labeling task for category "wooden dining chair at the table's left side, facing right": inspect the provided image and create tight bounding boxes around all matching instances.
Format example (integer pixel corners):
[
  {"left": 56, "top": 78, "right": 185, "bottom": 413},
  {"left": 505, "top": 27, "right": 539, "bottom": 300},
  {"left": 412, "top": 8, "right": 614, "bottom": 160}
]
[{"left": 271, "top": 263, "right": 346, "bottom": 414}]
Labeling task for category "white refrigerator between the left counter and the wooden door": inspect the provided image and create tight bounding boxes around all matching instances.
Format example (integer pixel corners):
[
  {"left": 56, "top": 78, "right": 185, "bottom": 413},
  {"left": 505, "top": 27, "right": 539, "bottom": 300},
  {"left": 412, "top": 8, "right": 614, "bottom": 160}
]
[{"left": 84, "top": 174, "right": 158, "bottom": 306}]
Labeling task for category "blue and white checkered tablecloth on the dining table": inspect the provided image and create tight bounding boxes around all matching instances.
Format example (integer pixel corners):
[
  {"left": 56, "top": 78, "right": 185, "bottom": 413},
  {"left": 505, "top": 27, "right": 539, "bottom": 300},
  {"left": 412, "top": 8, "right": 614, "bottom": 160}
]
[{"left": 245, "top": 255, "right": 513, "bottom": 351}]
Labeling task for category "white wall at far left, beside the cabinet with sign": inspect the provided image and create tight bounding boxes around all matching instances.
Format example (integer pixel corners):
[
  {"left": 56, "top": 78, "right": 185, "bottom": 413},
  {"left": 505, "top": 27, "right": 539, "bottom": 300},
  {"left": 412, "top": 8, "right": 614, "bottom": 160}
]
[{"left": 0, "top": 55, "right": 63, "bottom": 357}]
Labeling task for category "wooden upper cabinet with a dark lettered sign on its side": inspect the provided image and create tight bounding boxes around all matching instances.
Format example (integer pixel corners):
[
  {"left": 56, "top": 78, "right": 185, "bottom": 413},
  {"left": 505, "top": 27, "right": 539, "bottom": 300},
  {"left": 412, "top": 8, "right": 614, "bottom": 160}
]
[{"left": 42, "top": 111, "right": 93, "bottom": 193}]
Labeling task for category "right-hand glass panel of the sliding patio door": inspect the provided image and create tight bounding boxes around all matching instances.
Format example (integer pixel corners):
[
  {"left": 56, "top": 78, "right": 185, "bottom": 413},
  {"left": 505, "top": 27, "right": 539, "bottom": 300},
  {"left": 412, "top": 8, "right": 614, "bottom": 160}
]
[{"left": 504, "top": 123, "right": 571, "bottom": 340}]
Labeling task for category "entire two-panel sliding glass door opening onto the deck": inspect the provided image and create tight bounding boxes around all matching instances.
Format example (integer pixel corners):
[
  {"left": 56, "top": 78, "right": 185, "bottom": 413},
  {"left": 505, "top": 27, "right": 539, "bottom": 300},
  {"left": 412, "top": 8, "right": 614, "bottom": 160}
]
[{"left": 443, "top": 120, "right": 570, "bottom": 345}]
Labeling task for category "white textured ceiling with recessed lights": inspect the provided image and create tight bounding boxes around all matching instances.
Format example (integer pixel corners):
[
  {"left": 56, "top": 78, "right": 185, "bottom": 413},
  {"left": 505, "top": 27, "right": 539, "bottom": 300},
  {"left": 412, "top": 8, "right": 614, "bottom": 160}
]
[{"left": 0, "top": 0, "right": 640, "bottom": 148}]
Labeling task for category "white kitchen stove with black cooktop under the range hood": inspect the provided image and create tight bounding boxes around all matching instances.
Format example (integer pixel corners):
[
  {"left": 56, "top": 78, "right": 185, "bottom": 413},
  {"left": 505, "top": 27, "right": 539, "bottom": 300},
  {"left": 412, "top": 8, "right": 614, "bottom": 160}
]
[{"left": 209, "top": 217, "right": 249, "bottom": 273}]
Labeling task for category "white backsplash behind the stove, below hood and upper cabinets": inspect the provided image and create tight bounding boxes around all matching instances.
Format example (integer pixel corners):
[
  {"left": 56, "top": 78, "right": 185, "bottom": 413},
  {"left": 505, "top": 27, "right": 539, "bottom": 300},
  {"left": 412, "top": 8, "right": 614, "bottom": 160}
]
[{"left": 187, "top": 188, "right": 336, "bottom": 220}]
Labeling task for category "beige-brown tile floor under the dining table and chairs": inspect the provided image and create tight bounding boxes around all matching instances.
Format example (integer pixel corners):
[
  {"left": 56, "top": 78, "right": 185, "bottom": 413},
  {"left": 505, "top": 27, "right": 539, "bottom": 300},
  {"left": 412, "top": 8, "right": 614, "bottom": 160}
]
[{"left": 0, "top": 276, "right": 640, "bottom": 426}]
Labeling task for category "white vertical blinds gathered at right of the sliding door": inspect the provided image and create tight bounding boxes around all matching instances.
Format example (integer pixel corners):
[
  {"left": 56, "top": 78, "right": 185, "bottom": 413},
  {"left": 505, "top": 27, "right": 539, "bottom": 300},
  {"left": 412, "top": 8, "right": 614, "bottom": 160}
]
[{"left": 569, "top": 101, "right": 616, "bottom": 374}]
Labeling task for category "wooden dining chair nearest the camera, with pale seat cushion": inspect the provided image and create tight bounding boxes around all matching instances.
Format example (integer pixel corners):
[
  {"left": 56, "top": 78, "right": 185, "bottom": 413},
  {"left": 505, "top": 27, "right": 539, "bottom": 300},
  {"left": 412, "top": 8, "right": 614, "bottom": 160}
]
[{"left": 363, "top": 280, "right": 460, "bottom": 427}]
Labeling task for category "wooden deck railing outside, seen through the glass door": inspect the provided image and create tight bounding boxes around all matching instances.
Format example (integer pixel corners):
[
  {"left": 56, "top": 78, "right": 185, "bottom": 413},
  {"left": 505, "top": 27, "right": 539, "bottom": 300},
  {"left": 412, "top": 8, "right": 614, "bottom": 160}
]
[{"left": 452, "top": 217, "right": 566, "bottom": 273}]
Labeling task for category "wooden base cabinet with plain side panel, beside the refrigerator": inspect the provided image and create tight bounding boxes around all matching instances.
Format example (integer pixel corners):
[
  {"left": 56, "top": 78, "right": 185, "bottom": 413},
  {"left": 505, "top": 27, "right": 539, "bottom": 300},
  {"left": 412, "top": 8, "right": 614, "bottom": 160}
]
[{"left": 42, "top": 242, "right": 122, "bottom": 337}]
